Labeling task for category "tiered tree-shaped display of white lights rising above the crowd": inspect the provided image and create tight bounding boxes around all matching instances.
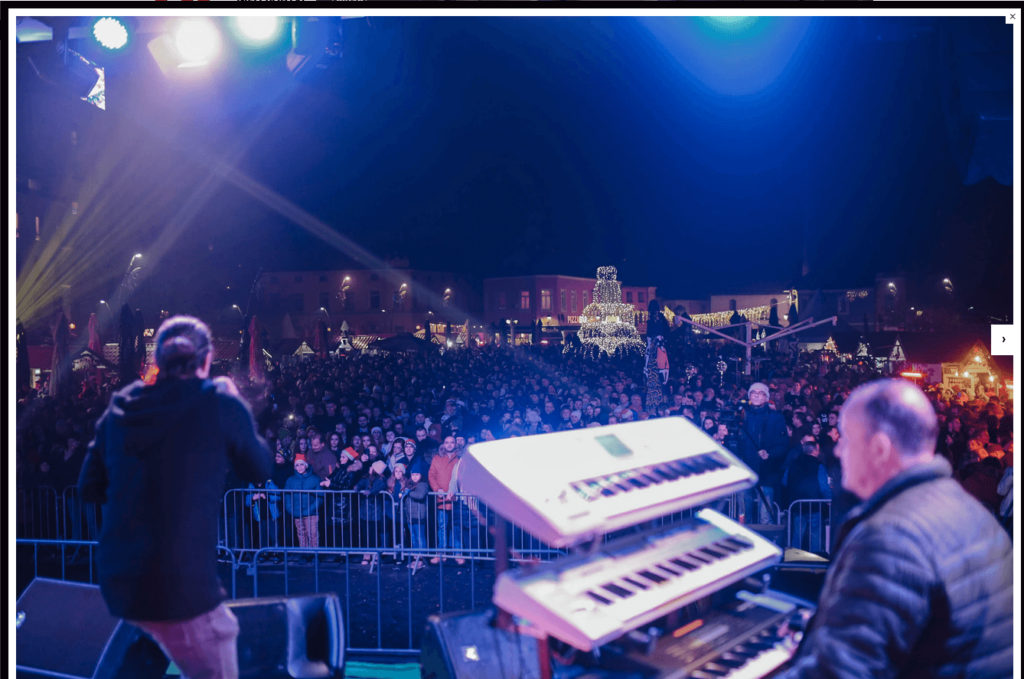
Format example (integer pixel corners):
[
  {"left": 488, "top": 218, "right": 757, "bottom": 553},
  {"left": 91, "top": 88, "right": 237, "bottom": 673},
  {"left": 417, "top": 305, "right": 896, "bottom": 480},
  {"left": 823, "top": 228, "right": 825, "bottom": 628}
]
[{"left": 566, "top": 266, "right": 645, "bottom": 355}]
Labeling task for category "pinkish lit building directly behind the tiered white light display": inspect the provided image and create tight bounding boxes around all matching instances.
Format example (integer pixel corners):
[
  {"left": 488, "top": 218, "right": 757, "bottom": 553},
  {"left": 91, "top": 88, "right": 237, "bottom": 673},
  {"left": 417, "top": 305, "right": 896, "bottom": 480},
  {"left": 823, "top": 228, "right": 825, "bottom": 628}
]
[{"left": 483, "top": 274, "right": 657, "bottom": 341}]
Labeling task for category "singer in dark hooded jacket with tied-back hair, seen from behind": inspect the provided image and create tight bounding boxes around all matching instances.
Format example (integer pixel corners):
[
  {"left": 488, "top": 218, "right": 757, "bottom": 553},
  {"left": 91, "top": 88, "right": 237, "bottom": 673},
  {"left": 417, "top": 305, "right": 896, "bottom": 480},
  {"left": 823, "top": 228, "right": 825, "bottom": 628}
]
[{"left": 79, "top": 316, "right": 272, "bottom": 679}]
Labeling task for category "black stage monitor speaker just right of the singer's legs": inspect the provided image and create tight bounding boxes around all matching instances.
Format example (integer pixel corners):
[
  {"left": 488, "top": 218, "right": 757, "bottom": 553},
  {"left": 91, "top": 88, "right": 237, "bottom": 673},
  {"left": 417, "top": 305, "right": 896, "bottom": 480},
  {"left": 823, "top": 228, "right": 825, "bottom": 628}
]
[{"left": 225, "top": 593, "right": 345, "bottom": 679}]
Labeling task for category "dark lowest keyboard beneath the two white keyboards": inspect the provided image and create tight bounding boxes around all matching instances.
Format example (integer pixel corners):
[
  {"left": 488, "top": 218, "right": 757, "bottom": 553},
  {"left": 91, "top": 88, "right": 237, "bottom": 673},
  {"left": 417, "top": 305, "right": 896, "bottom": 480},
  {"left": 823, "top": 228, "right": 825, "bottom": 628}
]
[{"left": 628, "top": 591, "right": 814, "bottom": 679}]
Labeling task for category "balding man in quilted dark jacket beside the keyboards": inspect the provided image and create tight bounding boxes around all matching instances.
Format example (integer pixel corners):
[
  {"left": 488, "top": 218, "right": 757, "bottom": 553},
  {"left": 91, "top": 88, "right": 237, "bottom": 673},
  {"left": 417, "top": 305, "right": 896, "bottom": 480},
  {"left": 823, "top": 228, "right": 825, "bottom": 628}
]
[{"left": 780, "top": 380, "right": 1015, "bottom": 679}]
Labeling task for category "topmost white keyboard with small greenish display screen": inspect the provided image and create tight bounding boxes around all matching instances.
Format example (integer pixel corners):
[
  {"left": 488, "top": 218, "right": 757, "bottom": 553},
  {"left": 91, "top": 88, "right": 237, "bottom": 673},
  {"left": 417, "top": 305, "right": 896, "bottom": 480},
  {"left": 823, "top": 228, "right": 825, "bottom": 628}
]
[{"left": 459, "top": 417, "right": 758, "bottom": 547}]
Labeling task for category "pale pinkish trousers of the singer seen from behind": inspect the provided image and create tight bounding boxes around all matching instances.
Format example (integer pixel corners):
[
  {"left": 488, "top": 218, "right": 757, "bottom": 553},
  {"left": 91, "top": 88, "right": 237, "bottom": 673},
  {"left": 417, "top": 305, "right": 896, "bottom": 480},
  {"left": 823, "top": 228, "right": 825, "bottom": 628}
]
[{"left": 128, "top": 603, "right": 239, "bottom": 679}]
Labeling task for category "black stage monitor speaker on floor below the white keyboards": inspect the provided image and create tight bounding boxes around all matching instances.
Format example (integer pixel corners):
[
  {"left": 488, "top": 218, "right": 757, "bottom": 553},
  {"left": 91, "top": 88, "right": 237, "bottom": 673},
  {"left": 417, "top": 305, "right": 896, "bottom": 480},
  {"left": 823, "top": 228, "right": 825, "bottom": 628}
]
[{"left": 420, "top": 608, "right": 541, "bottom": 679}]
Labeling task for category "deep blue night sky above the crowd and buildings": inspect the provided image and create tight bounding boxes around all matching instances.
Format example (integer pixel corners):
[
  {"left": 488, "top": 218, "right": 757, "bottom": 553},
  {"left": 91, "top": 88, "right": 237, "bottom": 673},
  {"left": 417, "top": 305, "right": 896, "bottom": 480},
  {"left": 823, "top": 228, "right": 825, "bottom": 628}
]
[{"left": 18, "top": 17, "right": 1013, "bottom": 313}]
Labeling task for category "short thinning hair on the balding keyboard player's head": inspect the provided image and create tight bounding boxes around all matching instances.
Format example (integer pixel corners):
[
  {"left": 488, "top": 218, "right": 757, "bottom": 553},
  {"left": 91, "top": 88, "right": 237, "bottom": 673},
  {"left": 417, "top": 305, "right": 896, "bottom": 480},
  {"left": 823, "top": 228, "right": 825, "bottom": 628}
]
[{"left": 861, "top": 379, "right": 939, "bottom": 455}]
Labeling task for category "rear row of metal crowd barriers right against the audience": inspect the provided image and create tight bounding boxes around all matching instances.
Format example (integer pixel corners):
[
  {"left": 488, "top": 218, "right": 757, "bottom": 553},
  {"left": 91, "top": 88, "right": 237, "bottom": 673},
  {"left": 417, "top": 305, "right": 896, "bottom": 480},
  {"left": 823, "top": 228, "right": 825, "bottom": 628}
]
[{"left": 16, "top": 486, "right": 833, "bottom": 561}]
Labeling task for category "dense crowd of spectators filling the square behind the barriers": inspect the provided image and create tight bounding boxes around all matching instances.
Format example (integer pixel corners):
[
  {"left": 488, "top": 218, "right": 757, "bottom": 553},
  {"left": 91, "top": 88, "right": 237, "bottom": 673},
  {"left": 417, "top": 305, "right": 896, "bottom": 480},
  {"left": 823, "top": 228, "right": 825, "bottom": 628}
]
[{"left": 17, "top": 323, "right": 1014, "bottom": 565}]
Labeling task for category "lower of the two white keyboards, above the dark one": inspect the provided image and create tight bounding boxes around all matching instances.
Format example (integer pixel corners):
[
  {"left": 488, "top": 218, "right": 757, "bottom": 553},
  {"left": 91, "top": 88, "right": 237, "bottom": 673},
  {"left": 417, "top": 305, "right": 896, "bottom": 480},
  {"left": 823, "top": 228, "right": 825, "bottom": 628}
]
[{"left": 494, "top": 509, "right": 782, "bottom": 650}]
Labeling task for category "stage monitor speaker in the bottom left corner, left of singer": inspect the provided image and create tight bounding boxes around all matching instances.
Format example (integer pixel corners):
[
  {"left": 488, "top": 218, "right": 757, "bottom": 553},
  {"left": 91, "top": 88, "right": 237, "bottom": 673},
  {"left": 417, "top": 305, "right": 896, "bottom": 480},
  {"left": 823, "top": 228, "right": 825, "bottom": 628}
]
[{"left": 15, "top": 578, "right": 169, "bottom": 679}]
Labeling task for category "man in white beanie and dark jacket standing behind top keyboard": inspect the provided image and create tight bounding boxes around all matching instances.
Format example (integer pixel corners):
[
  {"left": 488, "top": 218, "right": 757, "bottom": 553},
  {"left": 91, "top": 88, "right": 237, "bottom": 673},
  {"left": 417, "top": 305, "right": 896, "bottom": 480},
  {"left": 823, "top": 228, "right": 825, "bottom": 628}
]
[{"left": 739, "top": 382, "right": 790, "bottom": 523}]
